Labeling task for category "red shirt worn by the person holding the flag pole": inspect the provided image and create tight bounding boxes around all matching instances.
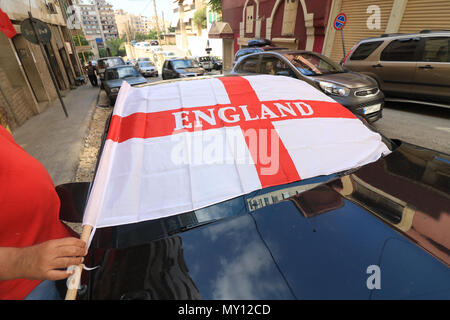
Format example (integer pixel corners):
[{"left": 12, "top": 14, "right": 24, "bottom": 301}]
[{"left": 0, "top": 126, "right": 73, "bottom": 299}]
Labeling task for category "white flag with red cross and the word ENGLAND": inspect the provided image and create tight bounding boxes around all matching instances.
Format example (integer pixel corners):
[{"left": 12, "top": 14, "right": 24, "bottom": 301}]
[{"left": 83, "top": 75, "right": 390, "bottom": 228}]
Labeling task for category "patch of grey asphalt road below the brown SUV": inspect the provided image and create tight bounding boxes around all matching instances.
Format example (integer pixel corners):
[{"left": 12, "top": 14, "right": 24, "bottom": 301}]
[{"left": 373, "top": 102, "right": 450, "bottom": 154}]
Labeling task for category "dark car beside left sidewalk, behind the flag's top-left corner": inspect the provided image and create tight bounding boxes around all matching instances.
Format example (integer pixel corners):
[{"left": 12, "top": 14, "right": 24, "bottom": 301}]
[{"left": 102, "top": 65, "right": 147, "bottom": 104}]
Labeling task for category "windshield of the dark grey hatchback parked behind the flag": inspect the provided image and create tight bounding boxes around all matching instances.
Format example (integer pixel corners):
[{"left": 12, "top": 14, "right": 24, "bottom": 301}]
[{"left": 284, "top": 53, "right": 345, "bottom": 76}]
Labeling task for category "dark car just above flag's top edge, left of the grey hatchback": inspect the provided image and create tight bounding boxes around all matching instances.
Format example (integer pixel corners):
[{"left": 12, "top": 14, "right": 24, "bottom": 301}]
[{"left": 162, "top": 58, "right": 205, "bottom": 80}]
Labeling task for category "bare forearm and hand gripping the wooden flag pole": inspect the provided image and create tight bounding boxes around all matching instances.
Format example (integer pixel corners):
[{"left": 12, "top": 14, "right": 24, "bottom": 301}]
[{"left": 0, "top": 238, "right": 87, "bottom": 280}]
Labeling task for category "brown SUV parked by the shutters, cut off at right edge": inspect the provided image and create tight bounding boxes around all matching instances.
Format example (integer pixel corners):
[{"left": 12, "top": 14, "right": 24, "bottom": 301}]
[{"left": 343, "top": 30, "right": 450, "bottom": 108}]
